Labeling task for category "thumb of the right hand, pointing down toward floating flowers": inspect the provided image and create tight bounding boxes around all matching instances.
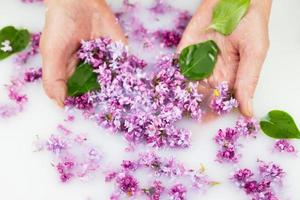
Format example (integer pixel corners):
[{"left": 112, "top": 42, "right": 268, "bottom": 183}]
[{"left": 235, "top": 46, "right": 267, "bottom": 117}]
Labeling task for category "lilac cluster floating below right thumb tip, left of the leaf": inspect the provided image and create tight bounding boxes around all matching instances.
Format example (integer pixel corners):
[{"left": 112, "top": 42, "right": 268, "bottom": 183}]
[{"left": 214, "top": 117, "right": 259, "bottom": 163}]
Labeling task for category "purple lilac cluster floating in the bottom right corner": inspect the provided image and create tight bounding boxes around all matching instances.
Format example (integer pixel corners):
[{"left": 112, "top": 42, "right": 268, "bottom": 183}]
[{"left": 232, "top": 161, "right": 285, "bottom": 200}]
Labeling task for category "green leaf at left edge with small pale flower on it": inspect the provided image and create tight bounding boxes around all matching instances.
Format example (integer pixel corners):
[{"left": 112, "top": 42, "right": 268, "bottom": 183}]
[{"left": 0, "top": 26, "right": 30, "bottom": 60}]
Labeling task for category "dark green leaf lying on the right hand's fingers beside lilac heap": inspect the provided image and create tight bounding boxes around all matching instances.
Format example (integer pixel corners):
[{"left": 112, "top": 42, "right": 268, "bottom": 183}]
[{"left": 179, "top": 40, "right": 219, "bottom": 80}]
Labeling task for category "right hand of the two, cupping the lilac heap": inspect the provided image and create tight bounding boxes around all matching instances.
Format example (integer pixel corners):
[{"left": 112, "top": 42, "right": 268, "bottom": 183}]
[{"left": 178, "top": 0, "right": 272, "bottom": 117}]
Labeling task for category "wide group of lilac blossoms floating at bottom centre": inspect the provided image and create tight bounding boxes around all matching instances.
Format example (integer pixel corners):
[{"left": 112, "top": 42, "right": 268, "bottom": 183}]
[{"left": 105, "top": 152, "right": 215, "bottom": 200}]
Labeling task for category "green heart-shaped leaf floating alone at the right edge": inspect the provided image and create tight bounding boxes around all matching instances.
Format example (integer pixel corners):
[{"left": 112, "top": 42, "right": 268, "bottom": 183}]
[{"left": 260, "top": 110, "right": 300, "bottom": 139}]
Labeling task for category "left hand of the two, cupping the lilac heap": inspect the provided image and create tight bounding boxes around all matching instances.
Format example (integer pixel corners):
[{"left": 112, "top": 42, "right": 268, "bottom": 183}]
[{"left": 41, "top": 0, "right": 126, "bottom": 106}]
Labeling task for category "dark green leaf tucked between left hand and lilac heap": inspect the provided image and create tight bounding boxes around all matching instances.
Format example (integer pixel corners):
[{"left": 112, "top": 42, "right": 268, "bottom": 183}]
[{"left": 67, "top": 63, "right": 100, "bottom": 96}]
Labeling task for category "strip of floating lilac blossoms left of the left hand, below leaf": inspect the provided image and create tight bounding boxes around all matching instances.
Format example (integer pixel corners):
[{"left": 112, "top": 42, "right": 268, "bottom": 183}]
[{"left": 0, "top": 33, "right": 42, "bottom": 118}]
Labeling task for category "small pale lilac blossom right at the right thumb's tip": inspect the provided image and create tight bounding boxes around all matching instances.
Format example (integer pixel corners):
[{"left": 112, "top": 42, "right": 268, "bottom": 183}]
[{"left": 235, "top": 117, "right": 259, "bottom": 137}]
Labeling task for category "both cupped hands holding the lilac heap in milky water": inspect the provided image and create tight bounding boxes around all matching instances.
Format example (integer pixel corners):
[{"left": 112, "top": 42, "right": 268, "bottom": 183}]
[{"left": 41, "top": 0, "right": 272, "bottom": 117}]
